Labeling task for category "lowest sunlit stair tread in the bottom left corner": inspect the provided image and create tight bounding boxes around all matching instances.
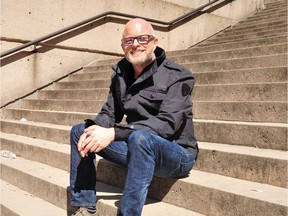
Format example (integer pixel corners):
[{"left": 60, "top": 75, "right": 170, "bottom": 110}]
[{"left": 0, "top": 180, "right": 67, "bottom": 216}]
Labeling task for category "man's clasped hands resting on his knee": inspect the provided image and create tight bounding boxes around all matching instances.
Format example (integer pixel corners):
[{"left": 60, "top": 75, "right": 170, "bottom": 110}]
[{"left": 78, "top": 125, "right": 115, "bottom": 157}]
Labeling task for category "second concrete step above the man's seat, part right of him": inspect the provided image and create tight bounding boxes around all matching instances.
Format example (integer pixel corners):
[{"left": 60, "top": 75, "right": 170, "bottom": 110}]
[{"left": 194, "top": 119, "right": 288, "bottom": 151}]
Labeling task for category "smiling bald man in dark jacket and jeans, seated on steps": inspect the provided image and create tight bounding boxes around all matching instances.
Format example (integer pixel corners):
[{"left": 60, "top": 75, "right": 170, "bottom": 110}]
[{"left": 70, "top": 18, "right": 198, "bottom": 216}]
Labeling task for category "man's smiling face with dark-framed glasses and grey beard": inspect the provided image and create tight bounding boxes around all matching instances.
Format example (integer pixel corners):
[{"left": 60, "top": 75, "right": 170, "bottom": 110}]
[{"left": 121, "top": 23, "right": 158, "bottom": 65}]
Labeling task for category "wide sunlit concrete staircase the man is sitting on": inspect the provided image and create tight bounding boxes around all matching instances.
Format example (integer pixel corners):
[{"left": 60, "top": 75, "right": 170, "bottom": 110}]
[{"left": 1, "top": 0, "right": 288, "bottom": 216}]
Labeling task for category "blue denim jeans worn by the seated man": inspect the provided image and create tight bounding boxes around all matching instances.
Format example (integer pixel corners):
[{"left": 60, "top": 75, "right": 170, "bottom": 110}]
[{"left": 70, "top": 124, "right": 195, "bottom": 216}]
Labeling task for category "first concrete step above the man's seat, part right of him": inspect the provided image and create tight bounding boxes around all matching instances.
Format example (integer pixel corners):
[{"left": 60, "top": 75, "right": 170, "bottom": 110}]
[{"left": 194, "top": 142, "right": 288, "bottom": 188}]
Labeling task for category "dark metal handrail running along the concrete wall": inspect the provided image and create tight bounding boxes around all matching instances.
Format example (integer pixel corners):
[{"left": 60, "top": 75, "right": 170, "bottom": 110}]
[{"left": 0, "top": 0, "right": 234, "bottom": 58}]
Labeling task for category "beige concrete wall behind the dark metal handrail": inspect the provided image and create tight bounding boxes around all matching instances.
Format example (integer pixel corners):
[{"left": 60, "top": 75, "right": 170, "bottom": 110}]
[{"left": 0, "top": 0, "right": 263, "bottom": 106}]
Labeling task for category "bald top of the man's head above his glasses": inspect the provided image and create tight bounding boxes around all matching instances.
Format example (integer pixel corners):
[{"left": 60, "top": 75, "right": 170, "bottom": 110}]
[{"left": 123, "top": 18, "right": 155, "bottom": 38}]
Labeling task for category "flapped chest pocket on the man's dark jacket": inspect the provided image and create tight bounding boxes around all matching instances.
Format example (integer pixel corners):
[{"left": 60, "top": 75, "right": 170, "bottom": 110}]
[{"left": 138, "top": 90, "right": 166, "bottom": 115}]
